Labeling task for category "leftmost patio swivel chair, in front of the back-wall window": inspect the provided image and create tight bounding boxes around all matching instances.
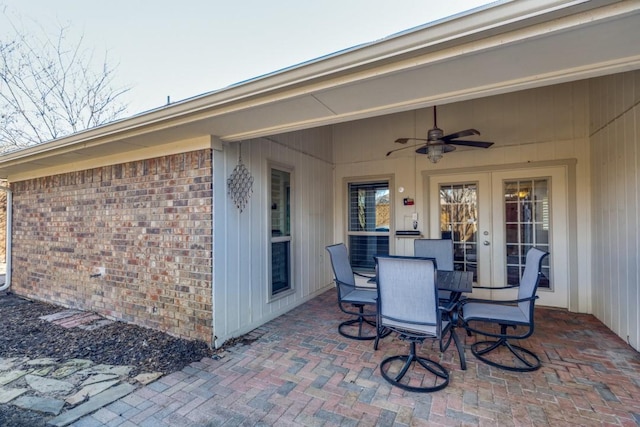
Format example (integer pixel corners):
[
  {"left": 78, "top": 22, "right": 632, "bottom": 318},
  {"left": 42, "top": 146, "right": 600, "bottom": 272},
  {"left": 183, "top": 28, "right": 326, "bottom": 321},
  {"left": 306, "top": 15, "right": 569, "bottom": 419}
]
[{"left": 326, "top": 243, "right": 378, "bottom": 340}]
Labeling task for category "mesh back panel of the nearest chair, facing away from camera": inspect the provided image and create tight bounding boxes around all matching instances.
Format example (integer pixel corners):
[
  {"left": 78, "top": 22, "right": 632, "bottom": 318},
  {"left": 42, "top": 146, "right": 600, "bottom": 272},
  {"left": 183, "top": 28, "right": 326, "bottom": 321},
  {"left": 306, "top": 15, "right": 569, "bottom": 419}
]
[{"left": 376, "top": 257, "right": 441, "bottom": 338}]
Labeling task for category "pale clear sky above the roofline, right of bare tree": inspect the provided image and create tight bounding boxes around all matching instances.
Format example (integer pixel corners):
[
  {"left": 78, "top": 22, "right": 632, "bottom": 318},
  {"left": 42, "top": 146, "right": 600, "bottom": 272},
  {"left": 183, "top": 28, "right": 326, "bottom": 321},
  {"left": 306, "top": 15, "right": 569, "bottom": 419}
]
[{"left": 0, "top": 0, "right": 491, "bottom": 115}]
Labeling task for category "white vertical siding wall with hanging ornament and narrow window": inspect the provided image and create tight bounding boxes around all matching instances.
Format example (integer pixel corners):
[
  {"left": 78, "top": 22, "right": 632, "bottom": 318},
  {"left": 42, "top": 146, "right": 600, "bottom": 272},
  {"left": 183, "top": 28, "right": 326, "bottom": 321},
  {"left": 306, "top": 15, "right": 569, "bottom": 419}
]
[{"left": 213, "top": 128, "right": 333, "bottom": 346}]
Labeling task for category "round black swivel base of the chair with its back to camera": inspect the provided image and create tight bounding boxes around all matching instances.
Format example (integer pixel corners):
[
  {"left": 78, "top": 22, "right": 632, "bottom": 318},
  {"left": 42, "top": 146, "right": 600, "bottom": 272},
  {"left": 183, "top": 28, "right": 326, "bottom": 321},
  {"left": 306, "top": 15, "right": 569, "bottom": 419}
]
[{"left": 380, "top": 340, "right": 449, "bottom": 393}]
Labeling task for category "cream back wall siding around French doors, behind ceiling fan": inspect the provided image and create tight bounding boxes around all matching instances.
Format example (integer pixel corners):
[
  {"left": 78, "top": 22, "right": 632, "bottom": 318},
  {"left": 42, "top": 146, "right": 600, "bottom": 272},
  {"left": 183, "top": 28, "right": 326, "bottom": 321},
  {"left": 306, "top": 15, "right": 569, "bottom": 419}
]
[{"left": 333, "top": 81, "right": 591, "bottom": 312}]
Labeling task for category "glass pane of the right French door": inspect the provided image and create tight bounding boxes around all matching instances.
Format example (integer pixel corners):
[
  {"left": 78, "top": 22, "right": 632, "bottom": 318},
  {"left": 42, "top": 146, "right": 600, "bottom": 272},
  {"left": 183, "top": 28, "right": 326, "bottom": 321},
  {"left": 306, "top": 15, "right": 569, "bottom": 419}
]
[{"left": 503, "top": 178, "right": 551, "bottom": 288}]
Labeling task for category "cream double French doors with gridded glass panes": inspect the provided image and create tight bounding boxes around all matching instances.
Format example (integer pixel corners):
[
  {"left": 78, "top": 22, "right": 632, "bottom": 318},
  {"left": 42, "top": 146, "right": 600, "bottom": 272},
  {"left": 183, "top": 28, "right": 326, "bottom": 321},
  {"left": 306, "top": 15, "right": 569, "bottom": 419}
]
[{"left": 429, "top": 166, "right": 569, "bottom": 308}]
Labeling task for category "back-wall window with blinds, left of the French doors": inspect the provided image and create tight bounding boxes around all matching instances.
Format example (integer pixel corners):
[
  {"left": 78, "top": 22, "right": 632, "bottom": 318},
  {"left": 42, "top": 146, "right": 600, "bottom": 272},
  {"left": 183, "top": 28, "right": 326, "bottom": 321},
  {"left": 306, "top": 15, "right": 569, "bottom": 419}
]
[{"left": 347, "top": 181, "right": 391, "bottom": 271}]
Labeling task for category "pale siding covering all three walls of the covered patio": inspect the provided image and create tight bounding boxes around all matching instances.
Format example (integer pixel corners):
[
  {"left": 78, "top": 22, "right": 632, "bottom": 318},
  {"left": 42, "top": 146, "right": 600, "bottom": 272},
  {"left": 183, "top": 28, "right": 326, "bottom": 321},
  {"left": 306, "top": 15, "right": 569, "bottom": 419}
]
[{"left": 214, "top": 72, "right": 640, "bottom": 349}]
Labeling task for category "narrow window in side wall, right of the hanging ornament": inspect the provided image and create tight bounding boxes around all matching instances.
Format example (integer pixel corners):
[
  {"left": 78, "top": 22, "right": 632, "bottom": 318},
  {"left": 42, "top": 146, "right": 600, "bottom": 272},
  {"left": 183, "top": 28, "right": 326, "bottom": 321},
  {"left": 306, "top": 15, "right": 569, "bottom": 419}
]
[{"left": 269, "top": 168, "right": 293, "bottom": 298}]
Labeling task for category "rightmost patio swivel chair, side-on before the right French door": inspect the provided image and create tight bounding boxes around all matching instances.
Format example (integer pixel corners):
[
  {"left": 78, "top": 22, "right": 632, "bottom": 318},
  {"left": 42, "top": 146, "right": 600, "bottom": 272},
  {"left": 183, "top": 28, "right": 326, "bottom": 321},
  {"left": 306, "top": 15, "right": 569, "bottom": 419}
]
[{"left": 461, "top": 247, "right": 549, "bottom": 372}]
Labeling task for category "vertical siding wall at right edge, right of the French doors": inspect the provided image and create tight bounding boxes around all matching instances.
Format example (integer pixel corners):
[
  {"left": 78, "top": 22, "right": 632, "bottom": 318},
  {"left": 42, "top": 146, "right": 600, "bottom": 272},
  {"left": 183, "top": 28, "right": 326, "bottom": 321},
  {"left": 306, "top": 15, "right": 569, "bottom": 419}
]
[{"left": 589, "top": 71, "right": 640, "bottom": 349}]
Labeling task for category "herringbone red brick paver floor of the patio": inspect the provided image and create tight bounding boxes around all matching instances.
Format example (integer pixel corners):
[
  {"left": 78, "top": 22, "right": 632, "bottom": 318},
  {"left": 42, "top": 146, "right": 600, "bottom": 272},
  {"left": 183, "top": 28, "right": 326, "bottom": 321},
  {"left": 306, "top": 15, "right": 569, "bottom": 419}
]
[{"left": 74, "top": 290, "right": 640, "bottom": 427}]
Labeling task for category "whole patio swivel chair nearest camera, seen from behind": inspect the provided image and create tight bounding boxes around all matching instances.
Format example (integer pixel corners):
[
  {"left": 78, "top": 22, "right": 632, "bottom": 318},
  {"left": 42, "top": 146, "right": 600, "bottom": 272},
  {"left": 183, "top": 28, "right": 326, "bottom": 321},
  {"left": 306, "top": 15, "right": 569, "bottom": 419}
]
[{"left": 374, "top": 256, "right": 464, "bottom": 392}]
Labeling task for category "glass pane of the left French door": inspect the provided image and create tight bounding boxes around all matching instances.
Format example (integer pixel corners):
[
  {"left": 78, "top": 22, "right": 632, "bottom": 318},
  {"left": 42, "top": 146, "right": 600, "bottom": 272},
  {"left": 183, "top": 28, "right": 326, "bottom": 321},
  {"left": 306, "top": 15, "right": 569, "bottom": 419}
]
[{"left": 440, "top": 183, "right": 478, "bottom": 280}]
